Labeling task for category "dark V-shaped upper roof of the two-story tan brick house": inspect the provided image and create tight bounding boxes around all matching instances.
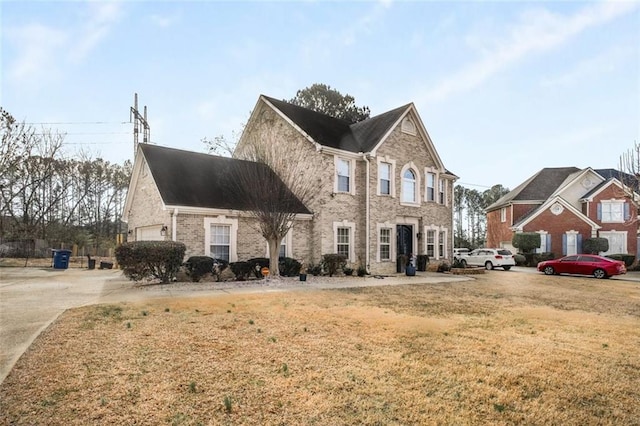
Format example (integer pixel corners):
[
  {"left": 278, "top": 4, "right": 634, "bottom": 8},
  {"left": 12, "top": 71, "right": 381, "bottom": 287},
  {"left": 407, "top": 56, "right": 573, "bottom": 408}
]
[{"left": 263, "top": 95, "right": 411, "bottom": 153}]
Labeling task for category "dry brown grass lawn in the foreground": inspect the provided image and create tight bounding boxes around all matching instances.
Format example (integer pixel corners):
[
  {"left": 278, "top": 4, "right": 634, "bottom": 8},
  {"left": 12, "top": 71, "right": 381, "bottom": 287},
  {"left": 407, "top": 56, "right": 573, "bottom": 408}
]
[{"left": 0, "top": 271, "right": 640, "bottom": 425}]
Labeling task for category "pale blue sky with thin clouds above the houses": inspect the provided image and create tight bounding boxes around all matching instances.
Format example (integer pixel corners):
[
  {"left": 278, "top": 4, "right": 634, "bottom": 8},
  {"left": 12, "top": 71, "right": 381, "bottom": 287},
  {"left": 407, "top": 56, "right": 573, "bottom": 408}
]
[{"left": 0, "top": 0, "right": 640, "bottom": 190}]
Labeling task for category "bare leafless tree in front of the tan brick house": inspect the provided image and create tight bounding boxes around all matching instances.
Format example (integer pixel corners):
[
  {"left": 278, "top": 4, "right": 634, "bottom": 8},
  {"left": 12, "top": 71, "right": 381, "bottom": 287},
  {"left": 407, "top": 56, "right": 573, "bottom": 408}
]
[{"left": 234, "top": 113, "right": 320, "bottom": 276}]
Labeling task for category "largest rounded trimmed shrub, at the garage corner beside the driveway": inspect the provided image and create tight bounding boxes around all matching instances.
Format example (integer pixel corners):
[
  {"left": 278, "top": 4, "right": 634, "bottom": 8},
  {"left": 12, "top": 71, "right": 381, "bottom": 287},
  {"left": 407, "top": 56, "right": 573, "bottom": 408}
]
[{"left": 115, "top": 241, "right": 186, "bottom": 283}]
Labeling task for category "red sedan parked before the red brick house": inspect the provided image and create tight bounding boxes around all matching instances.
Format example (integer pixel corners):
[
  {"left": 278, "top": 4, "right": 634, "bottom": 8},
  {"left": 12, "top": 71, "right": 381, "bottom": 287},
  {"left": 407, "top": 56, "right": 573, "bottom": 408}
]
[{"left": 538, "top": 254, "right": 627, "bottom": 278}]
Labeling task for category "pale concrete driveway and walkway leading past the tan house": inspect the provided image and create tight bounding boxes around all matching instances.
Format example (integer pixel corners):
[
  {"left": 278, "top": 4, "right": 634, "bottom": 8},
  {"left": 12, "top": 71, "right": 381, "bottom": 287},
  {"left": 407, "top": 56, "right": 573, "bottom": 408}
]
[{"left": 0, "top": 267, "right": 471, "bottom": 383}]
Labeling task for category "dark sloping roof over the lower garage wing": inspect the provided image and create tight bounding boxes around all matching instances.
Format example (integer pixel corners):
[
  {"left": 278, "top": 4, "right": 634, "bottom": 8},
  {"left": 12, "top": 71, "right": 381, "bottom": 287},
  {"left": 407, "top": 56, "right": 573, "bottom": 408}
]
[{"left": 139, "top": 144, "right": 310, "bottom": 214}]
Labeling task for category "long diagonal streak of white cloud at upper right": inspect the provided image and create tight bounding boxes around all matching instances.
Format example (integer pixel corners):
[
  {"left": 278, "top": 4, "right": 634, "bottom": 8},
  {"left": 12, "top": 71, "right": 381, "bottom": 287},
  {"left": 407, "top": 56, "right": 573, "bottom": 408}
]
[{"left": 423, "top": 2, "right": 638, "bottom": 103}]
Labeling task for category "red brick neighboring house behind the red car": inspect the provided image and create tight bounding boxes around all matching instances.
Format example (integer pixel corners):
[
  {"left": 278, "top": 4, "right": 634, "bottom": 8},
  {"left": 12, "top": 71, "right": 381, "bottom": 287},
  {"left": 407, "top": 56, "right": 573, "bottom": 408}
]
[{"left": 485, "top": 167, "right": 638, "bottom": 257}]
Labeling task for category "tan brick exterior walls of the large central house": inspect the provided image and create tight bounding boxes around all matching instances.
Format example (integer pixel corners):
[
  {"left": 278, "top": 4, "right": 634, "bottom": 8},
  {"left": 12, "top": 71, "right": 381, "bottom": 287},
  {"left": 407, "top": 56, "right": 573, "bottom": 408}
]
[{"left": 129, "top": 102, "right": 453, "bottom": 274}]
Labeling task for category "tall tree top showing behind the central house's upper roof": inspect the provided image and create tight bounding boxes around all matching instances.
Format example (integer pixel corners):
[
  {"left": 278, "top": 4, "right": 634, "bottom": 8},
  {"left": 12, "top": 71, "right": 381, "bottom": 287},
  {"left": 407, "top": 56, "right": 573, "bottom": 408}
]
[{"left": 285, "top": 83, "right": 371, "bottom": 123}]
